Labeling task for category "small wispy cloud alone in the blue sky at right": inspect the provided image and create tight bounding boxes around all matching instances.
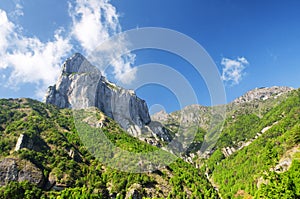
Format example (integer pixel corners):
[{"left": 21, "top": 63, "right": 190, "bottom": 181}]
[{"left": 221, "top": 57, "right": 249, "bottom": 85}]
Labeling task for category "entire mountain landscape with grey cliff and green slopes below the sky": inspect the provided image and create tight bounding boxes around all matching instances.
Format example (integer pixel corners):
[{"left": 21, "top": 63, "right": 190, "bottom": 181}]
[{"left": 0, "top": 53, "right": 300, "bottom": 198}]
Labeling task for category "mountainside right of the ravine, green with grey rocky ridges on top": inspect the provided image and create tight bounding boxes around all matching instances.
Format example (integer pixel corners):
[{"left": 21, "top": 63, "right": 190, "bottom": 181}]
[{"left": 152, "top": 87, "right": 300, "bottom": 198}]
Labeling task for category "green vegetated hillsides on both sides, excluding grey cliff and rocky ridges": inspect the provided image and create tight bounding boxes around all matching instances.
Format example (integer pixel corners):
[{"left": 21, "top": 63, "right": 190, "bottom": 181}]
[{"left": 0, "top": 90, "right": 300, "bottom": 199}]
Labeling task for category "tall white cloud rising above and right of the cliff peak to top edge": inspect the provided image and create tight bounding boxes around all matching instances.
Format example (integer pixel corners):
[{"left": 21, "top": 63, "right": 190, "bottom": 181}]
[{"left": 69, "top": 0, "right": 135, "bottom": 84}]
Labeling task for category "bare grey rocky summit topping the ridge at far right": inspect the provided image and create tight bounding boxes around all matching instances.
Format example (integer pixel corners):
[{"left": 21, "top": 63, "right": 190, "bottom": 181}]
[{"left": 232, "top": 86, "right": 294, "bottom": 103}]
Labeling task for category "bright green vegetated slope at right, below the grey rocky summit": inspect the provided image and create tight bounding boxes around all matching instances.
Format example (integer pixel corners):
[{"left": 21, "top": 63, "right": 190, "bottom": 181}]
[{"left": 206, "top": 90, "right": 300, "bottom": 198}]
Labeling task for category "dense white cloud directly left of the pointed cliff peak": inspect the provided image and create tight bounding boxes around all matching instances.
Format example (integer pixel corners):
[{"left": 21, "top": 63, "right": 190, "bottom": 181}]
[{"left": 6, "top": 33, "right": 72, "bottom": 93}]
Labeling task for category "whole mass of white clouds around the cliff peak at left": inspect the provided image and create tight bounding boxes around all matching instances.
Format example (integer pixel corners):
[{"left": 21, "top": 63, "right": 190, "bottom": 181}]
[{"left": 0, "top": 0, "right": 134, "bottom": 98}]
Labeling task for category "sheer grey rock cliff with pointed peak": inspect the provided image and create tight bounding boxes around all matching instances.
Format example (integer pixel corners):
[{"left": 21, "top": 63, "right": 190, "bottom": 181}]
[{"left": 45, "top": 53, "right": 170, "bottom": 141}]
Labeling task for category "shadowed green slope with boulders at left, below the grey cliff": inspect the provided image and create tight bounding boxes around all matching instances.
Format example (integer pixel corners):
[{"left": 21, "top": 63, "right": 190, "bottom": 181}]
[{"left": 0, "top": 99, "right": 217, "bottom": 198}]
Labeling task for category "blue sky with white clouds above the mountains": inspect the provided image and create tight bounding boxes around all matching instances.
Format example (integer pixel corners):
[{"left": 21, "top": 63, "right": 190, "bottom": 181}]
[{"left": 0, "top": 0, "right": 300, "bottom": 112}]
